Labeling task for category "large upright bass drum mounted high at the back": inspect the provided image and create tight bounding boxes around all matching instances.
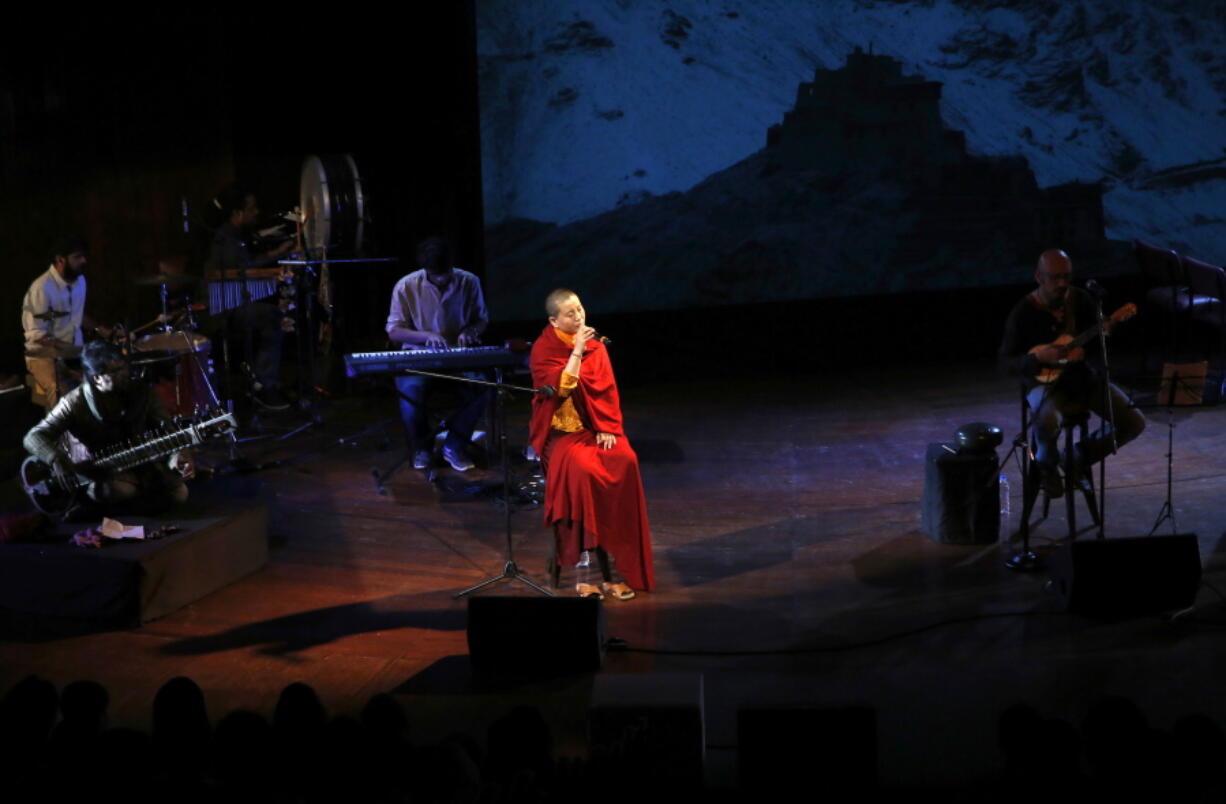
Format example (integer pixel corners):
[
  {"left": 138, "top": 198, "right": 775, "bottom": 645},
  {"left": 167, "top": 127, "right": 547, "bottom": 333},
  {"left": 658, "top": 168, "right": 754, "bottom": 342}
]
[{"left": 299, "top": 153, "right": 365, "bottom": 257}]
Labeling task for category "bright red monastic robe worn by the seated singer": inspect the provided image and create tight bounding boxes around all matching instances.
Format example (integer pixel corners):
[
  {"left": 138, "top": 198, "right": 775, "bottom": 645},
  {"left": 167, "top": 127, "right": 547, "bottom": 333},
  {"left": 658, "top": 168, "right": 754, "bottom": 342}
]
[{"left": 530, "top": 325, "right": 656, "bottom": 590}]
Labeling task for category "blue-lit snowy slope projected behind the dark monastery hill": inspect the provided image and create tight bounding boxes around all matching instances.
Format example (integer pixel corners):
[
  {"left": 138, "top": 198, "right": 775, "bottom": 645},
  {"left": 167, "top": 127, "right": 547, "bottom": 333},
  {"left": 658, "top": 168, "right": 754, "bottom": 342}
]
[{"left": 477, "top": 0, "right": 1226, "bottom": 261}]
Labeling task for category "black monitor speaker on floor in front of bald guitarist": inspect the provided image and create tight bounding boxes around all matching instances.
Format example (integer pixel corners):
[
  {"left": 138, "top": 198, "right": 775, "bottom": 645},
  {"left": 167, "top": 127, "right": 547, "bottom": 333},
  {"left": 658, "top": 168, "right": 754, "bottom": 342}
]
[{"left": 1052, "top": 533, "right": 1200, "bottom": 618}]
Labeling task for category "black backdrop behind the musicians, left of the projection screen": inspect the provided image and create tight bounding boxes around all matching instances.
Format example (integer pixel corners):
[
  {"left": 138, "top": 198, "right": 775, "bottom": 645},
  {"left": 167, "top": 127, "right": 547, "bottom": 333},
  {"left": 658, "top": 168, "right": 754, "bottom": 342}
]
[{"left": 0, "top": 2, "right": 482, "bottom": 373}]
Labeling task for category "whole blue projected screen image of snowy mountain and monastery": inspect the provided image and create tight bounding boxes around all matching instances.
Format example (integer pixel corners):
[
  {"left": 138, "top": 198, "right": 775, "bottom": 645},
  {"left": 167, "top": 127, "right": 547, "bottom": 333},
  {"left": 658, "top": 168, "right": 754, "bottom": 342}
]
[{"left": 478, "top": 0, "right": 1226, "bottom": 317}]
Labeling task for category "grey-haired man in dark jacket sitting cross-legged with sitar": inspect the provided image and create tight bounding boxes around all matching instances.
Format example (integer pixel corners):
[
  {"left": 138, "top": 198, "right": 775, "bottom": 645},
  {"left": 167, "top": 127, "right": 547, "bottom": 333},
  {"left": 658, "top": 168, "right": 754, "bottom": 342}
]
[{"left": 22, "top": 341, "right": 195, "bottom": 506}]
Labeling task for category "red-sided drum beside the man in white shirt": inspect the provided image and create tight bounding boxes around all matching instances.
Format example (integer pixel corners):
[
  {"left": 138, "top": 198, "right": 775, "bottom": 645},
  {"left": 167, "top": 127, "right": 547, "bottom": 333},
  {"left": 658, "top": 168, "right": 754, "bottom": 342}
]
[{"left": 131, "top": 331, "right": 215, "bottom": 418}]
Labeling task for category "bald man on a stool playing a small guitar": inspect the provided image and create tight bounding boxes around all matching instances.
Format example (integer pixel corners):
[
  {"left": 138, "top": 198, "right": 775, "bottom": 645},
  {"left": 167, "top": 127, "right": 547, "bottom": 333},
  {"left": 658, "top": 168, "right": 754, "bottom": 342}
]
[{"left": 999, "top": 249, "right": 1145, "bottom": 498}]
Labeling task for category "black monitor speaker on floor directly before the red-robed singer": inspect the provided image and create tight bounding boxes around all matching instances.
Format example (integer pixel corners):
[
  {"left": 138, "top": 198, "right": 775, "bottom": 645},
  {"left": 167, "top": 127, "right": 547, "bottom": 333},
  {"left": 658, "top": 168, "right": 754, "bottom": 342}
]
[{"left": 468, "top": 596, "right": 604, "bottom": 678}]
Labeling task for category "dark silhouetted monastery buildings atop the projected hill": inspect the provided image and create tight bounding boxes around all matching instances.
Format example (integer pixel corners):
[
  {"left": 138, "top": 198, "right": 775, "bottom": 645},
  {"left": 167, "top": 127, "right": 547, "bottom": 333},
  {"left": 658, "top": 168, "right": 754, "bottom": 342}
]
[{"left": 766, "top": 48, "right": 1106, "bottom": 258}]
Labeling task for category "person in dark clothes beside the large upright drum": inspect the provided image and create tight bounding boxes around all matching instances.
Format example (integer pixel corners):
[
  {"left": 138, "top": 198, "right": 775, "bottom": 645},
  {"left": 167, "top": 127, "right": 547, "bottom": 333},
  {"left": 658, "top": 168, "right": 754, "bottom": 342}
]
[{"left": 205, "top": 184, "right": 294, "bottom": 411}]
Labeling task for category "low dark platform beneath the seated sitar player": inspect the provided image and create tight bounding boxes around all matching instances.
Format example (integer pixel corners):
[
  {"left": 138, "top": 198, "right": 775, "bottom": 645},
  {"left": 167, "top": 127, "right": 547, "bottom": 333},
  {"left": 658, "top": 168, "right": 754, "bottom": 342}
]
[{"left": 0, "top": 482, "right": 268, "bottom": 628}]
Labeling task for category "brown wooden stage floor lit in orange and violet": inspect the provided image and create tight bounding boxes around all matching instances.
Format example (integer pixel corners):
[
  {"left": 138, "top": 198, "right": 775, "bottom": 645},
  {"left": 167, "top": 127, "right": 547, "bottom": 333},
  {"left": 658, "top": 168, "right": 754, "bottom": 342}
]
[{"left": 7, "top": 363, "right": 1226, "bottom": 784}]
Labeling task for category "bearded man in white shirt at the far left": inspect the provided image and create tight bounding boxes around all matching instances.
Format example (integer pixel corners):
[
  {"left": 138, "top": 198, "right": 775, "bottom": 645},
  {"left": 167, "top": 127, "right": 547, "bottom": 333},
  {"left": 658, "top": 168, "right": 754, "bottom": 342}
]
[{"left": 21, "top": 235, "right": 106, "bottom": 409}]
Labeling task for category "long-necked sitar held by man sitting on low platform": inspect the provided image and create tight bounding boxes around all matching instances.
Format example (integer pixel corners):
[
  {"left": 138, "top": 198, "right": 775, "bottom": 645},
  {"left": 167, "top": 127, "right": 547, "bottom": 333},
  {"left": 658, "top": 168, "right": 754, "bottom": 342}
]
[{"left": 20, "top": 413, "right": 238, "bottom": 516}]
